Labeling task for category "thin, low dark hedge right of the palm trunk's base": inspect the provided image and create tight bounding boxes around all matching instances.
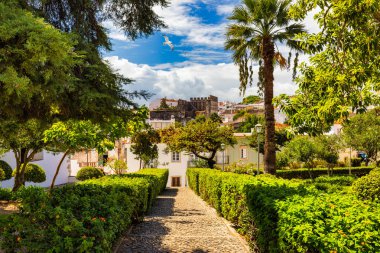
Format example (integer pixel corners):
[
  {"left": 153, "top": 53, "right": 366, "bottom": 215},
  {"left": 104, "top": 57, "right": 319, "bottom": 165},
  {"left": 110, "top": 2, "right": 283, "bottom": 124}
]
[{"left": 276, "top": 167, "right": 374, "bottom": 179}]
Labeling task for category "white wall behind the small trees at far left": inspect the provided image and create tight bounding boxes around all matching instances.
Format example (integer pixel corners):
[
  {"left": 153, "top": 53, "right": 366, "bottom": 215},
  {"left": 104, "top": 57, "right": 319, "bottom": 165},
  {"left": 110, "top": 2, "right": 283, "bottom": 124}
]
[{"left": 0, "top": 150, "right": 70, "bottom": 188}]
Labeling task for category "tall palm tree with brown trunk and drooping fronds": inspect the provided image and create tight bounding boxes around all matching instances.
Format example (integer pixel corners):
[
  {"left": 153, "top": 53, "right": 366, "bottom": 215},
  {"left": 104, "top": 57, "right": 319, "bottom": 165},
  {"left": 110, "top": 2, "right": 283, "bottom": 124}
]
[{"left": 225, "top": 0, "right": 305, "bottom": 174}]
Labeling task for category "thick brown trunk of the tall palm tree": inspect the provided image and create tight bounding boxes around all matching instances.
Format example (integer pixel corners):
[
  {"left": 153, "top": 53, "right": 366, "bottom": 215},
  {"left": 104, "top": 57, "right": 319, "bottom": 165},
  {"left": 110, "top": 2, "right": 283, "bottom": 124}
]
[{"left": 263, "top": 38, "right": 276, "bottom": 174}]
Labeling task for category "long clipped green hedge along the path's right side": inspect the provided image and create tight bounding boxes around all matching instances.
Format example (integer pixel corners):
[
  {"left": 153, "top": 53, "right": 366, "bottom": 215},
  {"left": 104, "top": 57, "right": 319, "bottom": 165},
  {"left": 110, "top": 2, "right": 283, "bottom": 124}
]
[{"left": 187, "top": 169, "right": 380, "bottom": 252}]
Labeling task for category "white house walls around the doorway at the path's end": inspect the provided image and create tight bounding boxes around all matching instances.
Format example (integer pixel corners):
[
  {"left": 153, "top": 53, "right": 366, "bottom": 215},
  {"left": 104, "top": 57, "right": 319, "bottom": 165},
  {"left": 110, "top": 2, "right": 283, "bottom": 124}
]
[{"left": 124, "top": 143, "right": 190, "bottom": 187}]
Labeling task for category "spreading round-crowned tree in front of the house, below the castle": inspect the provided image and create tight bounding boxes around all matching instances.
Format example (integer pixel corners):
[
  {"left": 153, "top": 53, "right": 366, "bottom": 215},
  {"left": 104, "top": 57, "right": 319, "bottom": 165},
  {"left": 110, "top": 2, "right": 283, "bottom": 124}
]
[{"left": 161, "top": 116, "right": 236, "bottom": 168}]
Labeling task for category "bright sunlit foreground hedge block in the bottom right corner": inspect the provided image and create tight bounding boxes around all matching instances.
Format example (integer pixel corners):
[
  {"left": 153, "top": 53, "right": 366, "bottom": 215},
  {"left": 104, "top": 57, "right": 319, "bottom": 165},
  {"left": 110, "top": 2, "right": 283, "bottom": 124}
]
[{"left": 277, "top": 194, "right": 380, "bottom": 253}]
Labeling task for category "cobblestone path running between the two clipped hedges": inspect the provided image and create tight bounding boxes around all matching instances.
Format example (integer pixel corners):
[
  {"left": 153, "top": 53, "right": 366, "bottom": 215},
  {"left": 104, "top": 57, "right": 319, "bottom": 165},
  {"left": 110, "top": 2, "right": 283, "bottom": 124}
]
[{"left": 115, "top": 188, "right": 249, "bottom": 253}]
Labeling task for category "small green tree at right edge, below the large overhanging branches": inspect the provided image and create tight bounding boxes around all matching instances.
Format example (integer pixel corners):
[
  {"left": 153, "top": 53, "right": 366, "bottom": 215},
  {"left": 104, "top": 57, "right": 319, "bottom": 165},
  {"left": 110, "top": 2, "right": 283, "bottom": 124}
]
[{"left": 343, "top": 109, "right": 380, "bottom": 163}]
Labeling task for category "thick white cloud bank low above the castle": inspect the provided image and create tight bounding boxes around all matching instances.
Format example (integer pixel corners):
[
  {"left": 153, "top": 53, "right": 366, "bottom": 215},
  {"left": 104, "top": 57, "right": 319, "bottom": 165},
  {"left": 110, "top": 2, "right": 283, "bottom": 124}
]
[{"left": 106, "top": 56, "right": 297, "bottom": 105}]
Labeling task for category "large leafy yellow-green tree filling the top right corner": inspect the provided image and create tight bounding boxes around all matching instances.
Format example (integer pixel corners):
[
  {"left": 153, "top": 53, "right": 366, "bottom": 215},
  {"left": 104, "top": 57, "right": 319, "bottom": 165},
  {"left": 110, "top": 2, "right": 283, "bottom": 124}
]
[{"left": 277, "top": 0, "right": 380, "bottom": 135}]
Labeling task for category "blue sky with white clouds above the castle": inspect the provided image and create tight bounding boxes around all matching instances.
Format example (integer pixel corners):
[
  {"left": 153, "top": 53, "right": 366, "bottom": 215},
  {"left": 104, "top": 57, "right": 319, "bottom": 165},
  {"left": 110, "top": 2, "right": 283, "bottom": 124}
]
[{"left": 104, "top": 0, "right": 316, "bottom": 104}]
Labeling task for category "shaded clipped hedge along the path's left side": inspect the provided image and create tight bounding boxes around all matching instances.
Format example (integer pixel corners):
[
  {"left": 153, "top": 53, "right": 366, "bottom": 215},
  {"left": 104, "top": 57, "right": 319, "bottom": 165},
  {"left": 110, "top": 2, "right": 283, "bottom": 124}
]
[{"left": 1, "top": 169, "right": 168, "bottom": 252}]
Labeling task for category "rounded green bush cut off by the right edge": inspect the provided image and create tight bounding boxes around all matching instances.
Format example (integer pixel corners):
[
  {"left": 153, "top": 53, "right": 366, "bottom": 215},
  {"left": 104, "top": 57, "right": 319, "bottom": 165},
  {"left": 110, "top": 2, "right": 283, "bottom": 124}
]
[{"left": 352, "top": 170, "right": 380, "bottom": 200}]
